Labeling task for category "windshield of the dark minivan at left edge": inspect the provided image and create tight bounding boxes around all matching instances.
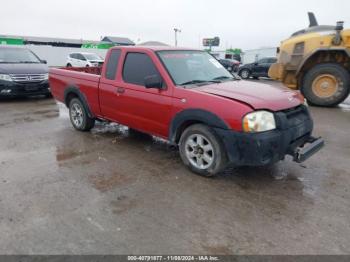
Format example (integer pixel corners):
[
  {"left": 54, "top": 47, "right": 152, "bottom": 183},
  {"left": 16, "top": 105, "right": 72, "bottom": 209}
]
[{"left": 0, "top": 48, "right": 41, "bottom": 64}]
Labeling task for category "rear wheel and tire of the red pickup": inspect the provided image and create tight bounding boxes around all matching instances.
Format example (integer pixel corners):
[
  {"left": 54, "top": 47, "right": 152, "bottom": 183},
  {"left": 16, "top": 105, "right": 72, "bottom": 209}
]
[{"left": 69, "top": 98, "right": 95, "bottom": 132}]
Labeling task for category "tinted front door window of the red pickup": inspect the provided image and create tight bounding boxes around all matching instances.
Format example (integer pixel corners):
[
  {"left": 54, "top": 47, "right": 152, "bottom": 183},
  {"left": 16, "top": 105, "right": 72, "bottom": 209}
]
[{"left": 123, "top": 53, "right": 160, "bottom": 86}]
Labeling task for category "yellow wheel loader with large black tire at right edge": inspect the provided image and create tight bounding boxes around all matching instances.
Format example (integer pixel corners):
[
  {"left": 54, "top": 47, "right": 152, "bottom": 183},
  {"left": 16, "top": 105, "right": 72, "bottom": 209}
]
[{"left": 269, "top": 13, "right": 350, "bottom": 107}]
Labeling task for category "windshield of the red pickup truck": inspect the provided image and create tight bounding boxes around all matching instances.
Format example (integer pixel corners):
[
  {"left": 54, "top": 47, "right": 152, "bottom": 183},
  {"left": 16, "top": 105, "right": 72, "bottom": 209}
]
[{"left": 157, "top": 50, "right": 233, "bottom": 85}]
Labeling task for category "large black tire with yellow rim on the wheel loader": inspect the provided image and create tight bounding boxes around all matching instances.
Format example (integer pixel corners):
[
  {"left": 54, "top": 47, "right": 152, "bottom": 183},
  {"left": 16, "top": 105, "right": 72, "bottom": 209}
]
[{"left": 300, "top": 63, "right": 350, "bottom": 107}]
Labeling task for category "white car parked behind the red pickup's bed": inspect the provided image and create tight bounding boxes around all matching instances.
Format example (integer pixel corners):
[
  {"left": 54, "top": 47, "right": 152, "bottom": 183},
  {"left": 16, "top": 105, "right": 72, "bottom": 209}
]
[{"left": 67, "top": 53, "right": 103, "bottom": 67}]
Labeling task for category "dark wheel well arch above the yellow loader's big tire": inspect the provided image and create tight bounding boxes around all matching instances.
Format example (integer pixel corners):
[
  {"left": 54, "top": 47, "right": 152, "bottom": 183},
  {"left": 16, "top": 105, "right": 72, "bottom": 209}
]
[{"left": 298, "top": 50, "right": 350, "bottom": 86}]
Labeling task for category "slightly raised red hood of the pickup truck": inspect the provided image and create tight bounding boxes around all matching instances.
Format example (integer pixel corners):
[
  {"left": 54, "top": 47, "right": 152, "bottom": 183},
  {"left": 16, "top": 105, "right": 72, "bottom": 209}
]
[{"left": 194, "top": 80, "right": 304, "bottom": 111}]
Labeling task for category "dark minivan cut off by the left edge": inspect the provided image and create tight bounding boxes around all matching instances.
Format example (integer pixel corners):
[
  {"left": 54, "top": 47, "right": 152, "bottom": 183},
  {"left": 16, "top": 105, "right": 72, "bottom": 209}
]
[{"left": 0, "top": 46, "right": 51, "bottom": 97}]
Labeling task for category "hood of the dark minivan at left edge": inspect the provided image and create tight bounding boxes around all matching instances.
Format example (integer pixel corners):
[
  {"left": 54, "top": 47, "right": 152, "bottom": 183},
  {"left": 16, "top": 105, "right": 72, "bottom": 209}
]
[{"left": 0, "top": 63, "right": 49, "bottom": 74}]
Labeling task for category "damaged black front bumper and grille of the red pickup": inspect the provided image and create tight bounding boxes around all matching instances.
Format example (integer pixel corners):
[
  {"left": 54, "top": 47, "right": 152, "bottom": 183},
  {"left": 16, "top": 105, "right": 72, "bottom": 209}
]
[{"left": 216, "top": 106, "right": 324, "bottom": 166}]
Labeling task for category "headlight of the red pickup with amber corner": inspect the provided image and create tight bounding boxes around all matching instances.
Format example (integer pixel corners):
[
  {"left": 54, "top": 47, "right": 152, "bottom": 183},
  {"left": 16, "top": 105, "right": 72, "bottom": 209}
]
[{"left": 243, "top": 111, "right": 276, "bottom": 132}]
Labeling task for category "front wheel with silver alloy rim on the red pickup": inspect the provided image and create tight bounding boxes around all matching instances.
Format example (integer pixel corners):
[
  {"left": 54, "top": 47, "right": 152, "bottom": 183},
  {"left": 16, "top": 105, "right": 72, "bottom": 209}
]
[{"left": 179, "top": 124, "right": 228, "bottom": 177}]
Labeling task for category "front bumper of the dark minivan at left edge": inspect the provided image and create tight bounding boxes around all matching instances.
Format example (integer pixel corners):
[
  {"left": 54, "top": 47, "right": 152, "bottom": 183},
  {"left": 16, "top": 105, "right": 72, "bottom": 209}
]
[{"left": 0, "top": 80, "right": 50, "bottom": 97}]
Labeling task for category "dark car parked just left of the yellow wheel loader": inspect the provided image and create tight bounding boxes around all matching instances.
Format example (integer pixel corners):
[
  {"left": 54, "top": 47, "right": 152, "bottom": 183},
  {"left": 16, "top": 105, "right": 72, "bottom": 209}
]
[{"left": 238, "top": 57, "right": 277, "bottom": 79}]
